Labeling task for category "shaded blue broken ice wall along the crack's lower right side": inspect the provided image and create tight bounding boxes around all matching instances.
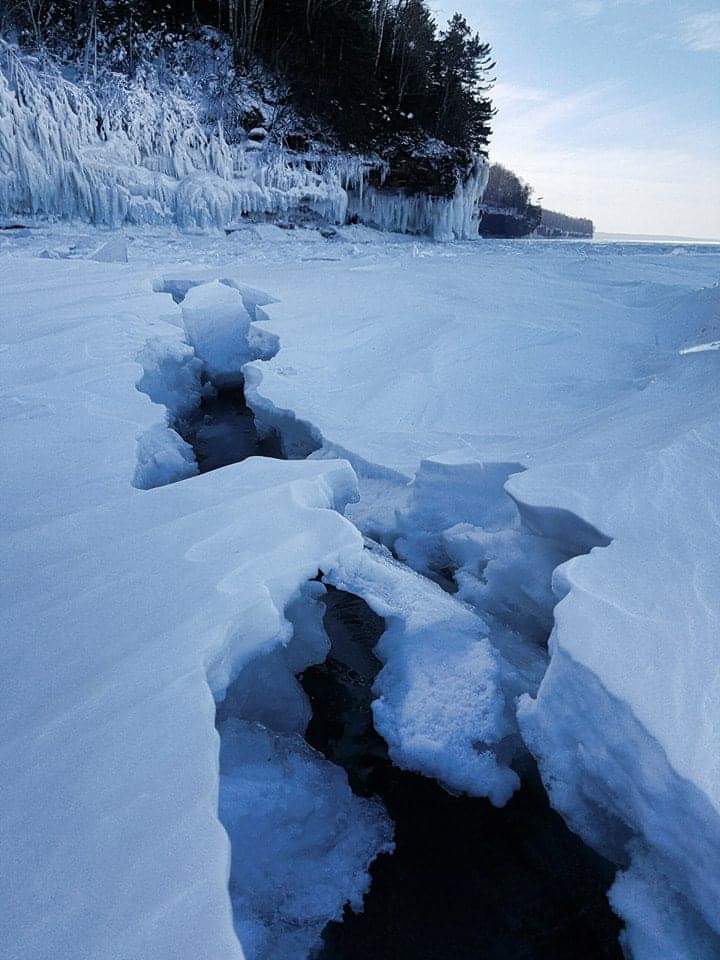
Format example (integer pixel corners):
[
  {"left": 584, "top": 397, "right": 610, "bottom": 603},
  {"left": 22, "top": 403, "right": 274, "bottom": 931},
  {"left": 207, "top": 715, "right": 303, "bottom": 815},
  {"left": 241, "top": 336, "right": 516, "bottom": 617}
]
[{"left": 520, "top": 648, "right": 720, "bottom": 960}]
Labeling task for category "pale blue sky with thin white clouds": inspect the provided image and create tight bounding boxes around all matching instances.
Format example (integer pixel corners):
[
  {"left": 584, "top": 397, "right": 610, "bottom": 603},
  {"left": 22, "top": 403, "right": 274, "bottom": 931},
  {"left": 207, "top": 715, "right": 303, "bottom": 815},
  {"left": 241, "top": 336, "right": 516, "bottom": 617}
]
[{"left": 433, "top": 0, "right": 720, "bottom": 239}]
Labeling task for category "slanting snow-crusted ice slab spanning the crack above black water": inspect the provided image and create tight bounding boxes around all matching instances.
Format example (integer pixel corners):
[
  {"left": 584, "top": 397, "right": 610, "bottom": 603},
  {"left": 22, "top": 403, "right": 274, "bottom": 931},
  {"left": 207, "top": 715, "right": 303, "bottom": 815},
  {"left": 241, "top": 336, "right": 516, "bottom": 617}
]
[{"left": 329, "top": 550, "right": 519, "bottom": 806}]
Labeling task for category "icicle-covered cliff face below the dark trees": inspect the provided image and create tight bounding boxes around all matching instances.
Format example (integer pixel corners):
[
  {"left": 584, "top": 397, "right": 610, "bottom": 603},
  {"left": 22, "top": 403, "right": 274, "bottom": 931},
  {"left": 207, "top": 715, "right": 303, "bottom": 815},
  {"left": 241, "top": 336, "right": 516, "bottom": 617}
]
[{"left": 0, "top": 40, "right": 487, "bottom": 239}]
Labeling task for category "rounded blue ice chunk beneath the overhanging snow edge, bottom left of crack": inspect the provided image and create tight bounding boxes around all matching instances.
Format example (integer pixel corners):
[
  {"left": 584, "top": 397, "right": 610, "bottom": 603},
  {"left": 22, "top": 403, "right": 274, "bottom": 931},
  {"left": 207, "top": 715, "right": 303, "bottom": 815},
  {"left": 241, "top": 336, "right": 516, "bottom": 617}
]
[{"left": 220, "top": 718, "right": 393, "bottom": 960}]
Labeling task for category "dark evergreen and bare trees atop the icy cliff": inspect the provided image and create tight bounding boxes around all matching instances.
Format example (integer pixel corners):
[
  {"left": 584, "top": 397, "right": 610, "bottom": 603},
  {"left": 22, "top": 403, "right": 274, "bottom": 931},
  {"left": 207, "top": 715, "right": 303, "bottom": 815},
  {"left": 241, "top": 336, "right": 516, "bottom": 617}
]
[{"left": 0, "top": 0, "right": 495, "bottom": 152}]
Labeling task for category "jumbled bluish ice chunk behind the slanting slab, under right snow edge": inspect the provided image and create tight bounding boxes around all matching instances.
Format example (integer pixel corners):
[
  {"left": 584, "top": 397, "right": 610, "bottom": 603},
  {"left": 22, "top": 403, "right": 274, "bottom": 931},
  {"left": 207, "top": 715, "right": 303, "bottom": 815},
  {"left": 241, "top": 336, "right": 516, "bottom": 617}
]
[{"left": 394, "top": 451, "right": 556, "bottom": 708}]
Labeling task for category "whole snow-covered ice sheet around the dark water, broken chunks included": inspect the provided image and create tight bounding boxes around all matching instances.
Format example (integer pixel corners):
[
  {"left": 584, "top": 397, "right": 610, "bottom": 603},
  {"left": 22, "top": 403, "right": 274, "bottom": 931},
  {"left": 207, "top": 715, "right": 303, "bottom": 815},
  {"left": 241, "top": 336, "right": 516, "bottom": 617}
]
[{"left": 0, "top": 224, "right": 720, "bottom": 960}]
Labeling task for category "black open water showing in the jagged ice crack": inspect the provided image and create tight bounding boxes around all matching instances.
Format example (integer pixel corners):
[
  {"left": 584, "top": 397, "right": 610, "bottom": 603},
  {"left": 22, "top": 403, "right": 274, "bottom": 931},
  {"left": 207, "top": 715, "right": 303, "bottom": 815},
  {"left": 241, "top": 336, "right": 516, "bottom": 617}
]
[{"left": 177, "top": 374, "right": 622, "bottom": 960}]
